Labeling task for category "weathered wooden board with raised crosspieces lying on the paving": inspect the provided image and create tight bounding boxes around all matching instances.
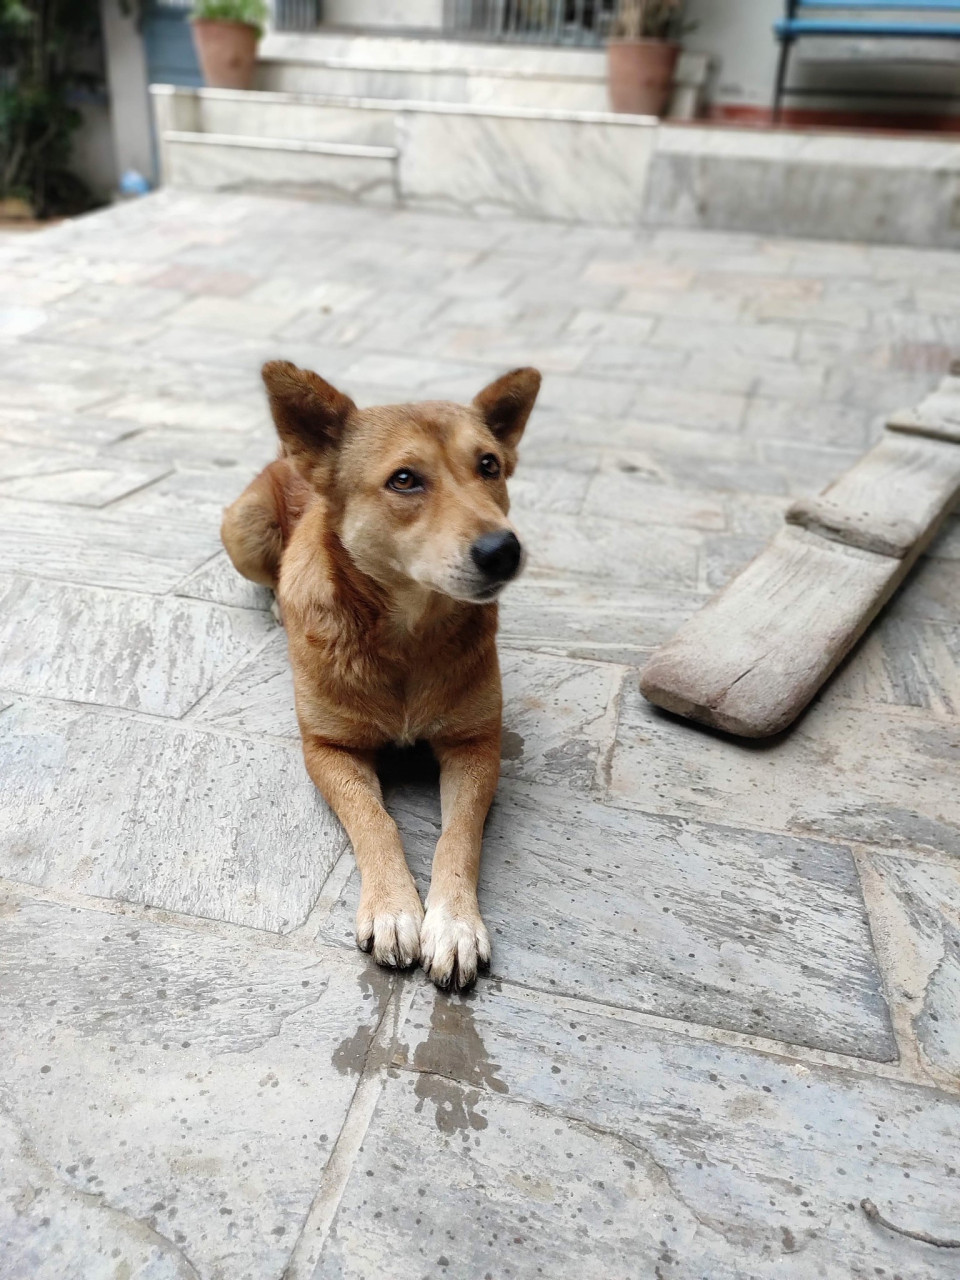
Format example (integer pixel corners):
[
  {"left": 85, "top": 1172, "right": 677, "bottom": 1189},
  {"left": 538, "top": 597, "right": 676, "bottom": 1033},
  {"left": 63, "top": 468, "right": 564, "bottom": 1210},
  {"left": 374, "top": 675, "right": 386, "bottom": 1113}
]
[{"left": 640, "top": 379, "right": 960, "bottom": 737}]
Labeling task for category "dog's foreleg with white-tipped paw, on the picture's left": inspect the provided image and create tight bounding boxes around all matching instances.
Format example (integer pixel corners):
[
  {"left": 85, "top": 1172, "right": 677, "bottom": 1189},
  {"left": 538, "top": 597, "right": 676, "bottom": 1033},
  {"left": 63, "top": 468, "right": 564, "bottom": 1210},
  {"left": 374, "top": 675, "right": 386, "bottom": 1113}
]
[{"left": 303, "top": 735, "right": 424, "bottom": 969}]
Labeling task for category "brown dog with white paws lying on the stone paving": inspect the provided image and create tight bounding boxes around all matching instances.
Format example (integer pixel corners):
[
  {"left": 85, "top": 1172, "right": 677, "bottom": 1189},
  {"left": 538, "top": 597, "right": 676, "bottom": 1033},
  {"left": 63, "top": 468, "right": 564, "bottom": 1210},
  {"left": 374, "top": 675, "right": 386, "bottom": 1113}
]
[{"left": 221, "top": 361, "right": 540, "bottom": 988}]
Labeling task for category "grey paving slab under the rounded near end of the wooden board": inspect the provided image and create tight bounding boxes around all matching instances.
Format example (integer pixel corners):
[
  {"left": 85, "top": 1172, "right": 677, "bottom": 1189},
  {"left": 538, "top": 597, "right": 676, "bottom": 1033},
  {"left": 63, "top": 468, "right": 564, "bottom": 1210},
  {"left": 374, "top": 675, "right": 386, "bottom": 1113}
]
[{"left": 609, "top": 681, "right": 960, "bottom": 855}]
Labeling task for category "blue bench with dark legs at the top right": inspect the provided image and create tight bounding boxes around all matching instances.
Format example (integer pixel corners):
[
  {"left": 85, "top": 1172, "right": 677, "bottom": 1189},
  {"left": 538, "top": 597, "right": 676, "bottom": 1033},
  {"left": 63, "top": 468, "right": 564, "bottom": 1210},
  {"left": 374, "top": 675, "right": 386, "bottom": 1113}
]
[{"left": 773, "top": 0, "right": 960, "bottom": 123}]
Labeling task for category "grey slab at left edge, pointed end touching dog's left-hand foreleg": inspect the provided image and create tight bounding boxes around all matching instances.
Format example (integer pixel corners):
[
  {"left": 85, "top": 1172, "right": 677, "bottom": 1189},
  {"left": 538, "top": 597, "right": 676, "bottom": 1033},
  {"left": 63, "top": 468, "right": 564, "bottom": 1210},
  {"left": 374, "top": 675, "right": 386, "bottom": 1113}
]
[{"left": 0, "top": 703, "right": 346, "bottom": 932}]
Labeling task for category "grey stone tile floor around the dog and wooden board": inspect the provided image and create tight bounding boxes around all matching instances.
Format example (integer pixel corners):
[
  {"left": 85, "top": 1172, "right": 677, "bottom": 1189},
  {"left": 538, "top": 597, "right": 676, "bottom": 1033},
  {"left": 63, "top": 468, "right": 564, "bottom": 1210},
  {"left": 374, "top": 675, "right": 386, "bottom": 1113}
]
[{"left": 0, "top": 193, "right": 960, "bottom": 1280}]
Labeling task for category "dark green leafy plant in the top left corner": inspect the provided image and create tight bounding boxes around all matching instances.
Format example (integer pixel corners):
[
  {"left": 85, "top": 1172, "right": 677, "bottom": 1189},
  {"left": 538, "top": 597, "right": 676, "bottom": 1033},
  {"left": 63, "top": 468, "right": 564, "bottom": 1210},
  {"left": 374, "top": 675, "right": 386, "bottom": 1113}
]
[{"left": 0, "top": 0, "right": 100, "bottom": 218}]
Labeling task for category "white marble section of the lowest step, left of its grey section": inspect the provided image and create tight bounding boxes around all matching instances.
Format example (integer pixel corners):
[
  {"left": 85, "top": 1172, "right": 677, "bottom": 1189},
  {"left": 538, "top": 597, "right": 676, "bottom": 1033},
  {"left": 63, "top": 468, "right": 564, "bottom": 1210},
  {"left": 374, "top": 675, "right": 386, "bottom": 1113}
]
[{"left": 151, "top": 84, "right": 657, "bottom": 225}]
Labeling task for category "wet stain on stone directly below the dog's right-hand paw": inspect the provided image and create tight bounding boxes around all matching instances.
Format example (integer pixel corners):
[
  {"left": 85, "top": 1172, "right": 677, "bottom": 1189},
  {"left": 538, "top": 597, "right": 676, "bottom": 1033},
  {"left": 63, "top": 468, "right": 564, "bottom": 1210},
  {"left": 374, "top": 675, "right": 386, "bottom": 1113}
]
[{"left": 413, "top": 995, "right": 509, "bottom": 1134}]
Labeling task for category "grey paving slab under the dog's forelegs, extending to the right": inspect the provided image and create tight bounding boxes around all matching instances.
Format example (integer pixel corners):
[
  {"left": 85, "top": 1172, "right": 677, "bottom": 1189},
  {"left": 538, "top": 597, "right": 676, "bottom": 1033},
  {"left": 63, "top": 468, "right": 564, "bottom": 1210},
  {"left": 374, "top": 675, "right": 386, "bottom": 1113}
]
[{"left": 324, "top": 777, "right": 896, "bottom": 1061}]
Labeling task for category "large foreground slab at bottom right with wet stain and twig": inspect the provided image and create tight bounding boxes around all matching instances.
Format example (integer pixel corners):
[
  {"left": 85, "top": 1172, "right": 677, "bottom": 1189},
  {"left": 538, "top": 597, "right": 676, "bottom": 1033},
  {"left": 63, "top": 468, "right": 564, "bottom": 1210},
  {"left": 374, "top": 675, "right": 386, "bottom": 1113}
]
[{"left": 314, "top": 986, "right": 959, "bottom": 1280}]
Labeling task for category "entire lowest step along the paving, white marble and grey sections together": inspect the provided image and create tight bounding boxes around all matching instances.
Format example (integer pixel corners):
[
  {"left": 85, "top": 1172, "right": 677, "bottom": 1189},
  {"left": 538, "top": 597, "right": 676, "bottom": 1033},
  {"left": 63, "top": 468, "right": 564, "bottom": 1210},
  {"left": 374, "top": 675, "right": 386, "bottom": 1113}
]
[{"left": 152, "top": 86, "right": 960, "bottom": 248}]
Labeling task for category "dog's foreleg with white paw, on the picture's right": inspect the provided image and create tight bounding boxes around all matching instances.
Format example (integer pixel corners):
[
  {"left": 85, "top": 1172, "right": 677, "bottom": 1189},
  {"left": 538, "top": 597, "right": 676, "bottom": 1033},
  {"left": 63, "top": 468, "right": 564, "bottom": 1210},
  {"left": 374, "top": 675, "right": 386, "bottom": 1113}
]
[{"left": 420, "top": 724, "right": 500, "bottom": 989}]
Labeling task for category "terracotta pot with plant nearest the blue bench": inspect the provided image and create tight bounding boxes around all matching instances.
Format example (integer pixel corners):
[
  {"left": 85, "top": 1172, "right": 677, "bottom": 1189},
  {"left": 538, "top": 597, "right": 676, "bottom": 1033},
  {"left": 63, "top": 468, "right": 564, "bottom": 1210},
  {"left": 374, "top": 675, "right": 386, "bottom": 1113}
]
[{"left": 607, "top": 0, "right": 684, "bottom": 115}]
